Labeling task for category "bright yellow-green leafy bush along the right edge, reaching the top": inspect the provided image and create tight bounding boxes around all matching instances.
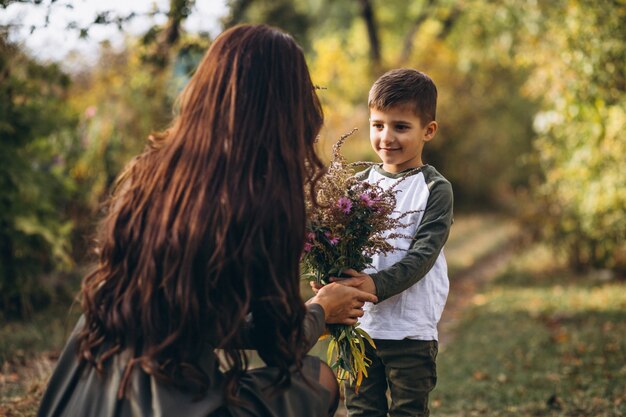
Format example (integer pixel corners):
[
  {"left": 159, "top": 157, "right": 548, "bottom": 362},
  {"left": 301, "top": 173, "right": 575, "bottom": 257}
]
[{"left": 502, "top": 1, "right": 626, "bottom": 271}]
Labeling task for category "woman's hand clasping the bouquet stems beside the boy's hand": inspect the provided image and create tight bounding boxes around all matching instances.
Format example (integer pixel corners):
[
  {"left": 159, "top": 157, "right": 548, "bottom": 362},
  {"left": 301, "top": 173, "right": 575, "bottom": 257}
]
[{"left": 308, "top": 282, "right": 378, "bottom": 325}]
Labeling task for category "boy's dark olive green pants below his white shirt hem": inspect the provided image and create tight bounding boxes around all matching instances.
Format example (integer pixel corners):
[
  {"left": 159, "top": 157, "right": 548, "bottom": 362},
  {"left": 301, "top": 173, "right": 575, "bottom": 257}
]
[{"left": 345, "top": 339, "right": 438, "bottom": 417}]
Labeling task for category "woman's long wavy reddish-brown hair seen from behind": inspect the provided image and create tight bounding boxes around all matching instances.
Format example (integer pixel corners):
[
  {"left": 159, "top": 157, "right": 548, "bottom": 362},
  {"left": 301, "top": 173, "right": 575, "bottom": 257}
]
[{"left": 79, "top": 25, "right": 323, "bottom": 399}]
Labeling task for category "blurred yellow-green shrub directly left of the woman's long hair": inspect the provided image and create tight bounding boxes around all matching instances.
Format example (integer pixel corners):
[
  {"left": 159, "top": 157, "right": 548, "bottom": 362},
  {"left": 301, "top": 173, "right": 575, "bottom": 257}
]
[{"left": 66, "top": 37, "right": 200, "bottom": 259}]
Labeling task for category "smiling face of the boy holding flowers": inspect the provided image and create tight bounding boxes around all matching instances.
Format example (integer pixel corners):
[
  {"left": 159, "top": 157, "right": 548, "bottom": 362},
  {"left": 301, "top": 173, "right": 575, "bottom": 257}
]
[{"left": 370, "top": 105, "right": 437, "bottom": 173}]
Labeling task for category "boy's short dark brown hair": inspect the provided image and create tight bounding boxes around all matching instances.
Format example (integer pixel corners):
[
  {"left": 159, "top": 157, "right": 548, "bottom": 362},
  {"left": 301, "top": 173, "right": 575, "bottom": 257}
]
[{"left": 367, "top": 68, "right": 437, "bottom": 123}]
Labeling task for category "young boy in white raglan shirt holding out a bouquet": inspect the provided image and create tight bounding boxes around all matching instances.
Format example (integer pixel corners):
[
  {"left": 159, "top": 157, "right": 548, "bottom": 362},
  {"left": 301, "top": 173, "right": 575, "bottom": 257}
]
[{"left": 344, "top": 69, "right": 452, "bottom": 417}]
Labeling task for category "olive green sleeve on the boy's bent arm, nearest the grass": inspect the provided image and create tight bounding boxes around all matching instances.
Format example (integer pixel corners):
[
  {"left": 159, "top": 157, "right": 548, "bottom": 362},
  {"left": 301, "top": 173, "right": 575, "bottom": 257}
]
[{"left": 370, "top": 177, "right": 453, "bottom": 302}]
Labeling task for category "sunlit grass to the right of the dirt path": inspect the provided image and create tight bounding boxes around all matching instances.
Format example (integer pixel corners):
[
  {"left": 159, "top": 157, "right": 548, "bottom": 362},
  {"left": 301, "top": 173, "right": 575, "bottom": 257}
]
[{"left": 431, "top": 245, "right": 626, "bottom": 417}]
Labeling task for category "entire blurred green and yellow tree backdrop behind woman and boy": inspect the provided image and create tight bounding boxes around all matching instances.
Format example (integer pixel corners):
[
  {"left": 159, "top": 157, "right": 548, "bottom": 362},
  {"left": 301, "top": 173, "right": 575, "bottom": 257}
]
[{"left": 0, "top": 0, "right": 626, "bottom": 314}]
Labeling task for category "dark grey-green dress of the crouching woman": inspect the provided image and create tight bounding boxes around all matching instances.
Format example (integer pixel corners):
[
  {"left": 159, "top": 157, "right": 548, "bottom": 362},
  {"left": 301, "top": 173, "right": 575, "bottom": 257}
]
[{"left": 37, "top": 304, "right": 330, "bottom": 417}]
